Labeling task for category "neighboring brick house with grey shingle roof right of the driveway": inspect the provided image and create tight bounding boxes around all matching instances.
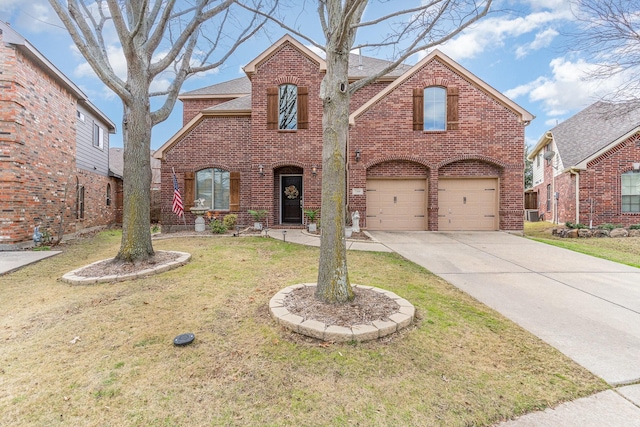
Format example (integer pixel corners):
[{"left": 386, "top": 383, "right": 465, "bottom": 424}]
[{"left": 529, "top": 102, "right": 640, "bottom": 227}]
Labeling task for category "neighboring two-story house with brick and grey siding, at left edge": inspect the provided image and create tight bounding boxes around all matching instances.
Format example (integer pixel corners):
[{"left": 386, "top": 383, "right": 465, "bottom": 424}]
[{"left": 0, "top": 21, "right": 116, "bottom": 249}]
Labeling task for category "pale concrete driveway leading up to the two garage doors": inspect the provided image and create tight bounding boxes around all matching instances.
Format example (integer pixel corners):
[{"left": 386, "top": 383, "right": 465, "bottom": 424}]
[{"left": 371, "top": 231, "right": 640, "bottom": 387}]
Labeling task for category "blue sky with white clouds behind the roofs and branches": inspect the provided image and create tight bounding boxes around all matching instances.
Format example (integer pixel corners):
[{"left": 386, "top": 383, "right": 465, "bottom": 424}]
[{"left": 0, "top": 0, "right": 632, "bottom": 149}]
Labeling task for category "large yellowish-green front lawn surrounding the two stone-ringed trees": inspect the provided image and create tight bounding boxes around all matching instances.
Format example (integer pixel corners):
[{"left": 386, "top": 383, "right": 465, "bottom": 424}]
[{"left": 0, "top": 231, "right": 607, "bottom": 426}]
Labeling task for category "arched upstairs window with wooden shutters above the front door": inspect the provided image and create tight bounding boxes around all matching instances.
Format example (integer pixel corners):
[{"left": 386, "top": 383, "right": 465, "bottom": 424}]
[{"left": 267, "top": 83, "right": 309, "bottom": 130}]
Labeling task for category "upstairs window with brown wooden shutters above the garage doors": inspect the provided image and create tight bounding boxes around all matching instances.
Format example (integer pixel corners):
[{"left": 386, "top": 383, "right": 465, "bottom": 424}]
[{"left": 413, "top": 86, "right": 459, "bottom": 132}]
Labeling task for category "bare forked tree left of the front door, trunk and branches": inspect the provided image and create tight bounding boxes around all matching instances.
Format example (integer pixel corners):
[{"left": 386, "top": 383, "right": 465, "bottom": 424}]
[{"left": 49, "top": 0, "right": 270, "bottom": 262}]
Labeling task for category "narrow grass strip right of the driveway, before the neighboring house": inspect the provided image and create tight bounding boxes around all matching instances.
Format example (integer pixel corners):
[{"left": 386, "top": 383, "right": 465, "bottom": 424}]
[{"left": 524, "top": 221, "right": 640, "bottom": 268}]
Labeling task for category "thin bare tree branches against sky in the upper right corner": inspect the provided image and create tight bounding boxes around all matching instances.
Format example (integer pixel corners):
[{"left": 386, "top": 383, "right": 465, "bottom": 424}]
[{"left": 569, "top": 0, "right": 640, "bottom": 103}]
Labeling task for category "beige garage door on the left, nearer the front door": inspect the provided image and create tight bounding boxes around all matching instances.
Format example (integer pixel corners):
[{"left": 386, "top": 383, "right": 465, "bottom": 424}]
[{"left": 367, "top": 178, "right": 427, "bottom": 230}]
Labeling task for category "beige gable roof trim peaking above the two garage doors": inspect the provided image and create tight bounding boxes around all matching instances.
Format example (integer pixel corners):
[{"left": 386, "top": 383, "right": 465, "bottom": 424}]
[{"left": 349, "top": 49, "right": 535, "bottom": 125}]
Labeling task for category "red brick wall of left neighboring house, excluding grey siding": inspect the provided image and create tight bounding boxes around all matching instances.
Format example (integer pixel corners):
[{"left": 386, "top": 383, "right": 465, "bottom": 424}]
[{"left": 0, "top": 26, "right": 118, "bottom": 249}]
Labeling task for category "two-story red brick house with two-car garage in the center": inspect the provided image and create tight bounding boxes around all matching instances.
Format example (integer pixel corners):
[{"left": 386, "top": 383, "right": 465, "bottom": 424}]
[{"left": 155, "top": 36, "right": 533, "bottom": 231}]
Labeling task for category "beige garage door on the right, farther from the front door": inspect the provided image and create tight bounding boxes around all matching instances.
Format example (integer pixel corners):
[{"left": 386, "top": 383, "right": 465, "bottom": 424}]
[{"left": 438, "top": 178, "right": 498, "bottom": 231}]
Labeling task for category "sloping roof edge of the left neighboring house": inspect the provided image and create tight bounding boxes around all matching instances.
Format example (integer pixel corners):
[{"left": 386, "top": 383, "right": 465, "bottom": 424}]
[{"left": 0, "top": 20, "right": 116, "bottom": 133}]
